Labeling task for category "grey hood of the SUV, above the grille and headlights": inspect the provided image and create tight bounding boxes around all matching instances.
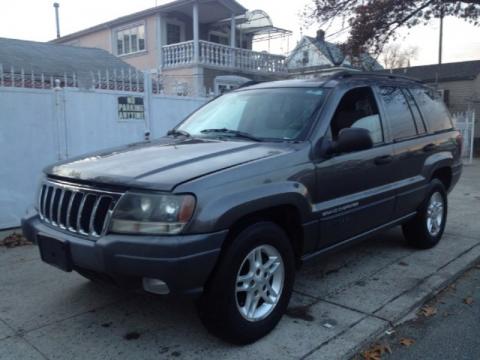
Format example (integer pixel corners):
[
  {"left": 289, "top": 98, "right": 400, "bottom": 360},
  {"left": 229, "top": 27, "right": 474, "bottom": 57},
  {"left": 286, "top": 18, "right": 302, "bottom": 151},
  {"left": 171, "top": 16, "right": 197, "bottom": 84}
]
[{"left": 45, "top": 138, "right": 288, "bottom": 191}]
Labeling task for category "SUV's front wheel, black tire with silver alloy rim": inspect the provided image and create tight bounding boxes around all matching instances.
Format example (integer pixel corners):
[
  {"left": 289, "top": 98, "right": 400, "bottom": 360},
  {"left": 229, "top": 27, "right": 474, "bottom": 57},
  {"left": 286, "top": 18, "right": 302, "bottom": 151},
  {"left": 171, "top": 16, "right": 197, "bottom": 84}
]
[{"left": 197, "top": 222, "right": 295, "bottom": 345}]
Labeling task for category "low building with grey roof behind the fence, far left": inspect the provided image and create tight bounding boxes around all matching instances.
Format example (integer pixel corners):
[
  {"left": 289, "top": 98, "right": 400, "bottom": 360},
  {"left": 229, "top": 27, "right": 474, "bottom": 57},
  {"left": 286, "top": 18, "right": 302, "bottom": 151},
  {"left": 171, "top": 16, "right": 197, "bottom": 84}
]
[{"left": 0, "top": 38, "right": 138, "bottom": 88}]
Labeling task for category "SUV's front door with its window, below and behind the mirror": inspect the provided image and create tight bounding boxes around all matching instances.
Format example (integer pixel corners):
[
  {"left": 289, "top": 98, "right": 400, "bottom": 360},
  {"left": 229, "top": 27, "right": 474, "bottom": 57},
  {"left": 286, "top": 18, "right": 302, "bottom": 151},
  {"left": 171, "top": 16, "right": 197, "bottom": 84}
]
[{"left": 314, "top": 86, "right": 395, "bottom": 248}]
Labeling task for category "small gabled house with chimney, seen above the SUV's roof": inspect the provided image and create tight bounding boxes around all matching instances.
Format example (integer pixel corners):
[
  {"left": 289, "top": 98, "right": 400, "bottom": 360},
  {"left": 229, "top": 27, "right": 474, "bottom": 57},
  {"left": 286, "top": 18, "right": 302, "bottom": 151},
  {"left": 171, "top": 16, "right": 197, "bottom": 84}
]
[{"left": 286, "top": 30, "right": 383, "bottom": 78}]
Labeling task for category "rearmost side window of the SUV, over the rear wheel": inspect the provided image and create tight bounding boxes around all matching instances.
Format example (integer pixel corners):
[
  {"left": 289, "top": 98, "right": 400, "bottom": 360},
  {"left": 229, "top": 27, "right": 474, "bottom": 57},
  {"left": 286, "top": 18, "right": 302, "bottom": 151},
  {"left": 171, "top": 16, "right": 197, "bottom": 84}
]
[{"left": 410, "top": 88, "right": 453, "bottom": 132}]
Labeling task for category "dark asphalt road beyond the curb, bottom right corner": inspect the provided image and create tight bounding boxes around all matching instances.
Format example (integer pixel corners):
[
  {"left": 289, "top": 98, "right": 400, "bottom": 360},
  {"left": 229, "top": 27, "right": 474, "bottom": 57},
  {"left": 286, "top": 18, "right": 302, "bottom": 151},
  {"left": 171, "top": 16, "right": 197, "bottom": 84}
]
[{"left": 360, "top": 263, "right": 480, "bottom": 360}]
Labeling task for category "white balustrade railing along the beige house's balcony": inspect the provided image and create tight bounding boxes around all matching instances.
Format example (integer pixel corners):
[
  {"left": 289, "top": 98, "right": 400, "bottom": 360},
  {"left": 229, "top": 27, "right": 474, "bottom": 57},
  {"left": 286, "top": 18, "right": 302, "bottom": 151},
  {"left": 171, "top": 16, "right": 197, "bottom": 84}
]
[{"left": 163, "top": 40, "right": 287, "bottom": 73}]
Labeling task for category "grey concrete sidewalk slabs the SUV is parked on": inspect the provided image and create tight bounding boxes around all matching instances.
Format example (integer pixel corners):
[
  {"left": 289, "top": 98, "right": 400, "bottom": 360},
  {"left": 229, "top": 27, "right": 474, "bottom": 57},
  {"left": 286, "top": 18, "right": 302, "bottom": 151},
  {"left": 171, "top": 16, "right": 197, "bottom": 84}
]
[{"left": 0, "top": 162, "right": 480, "bottom": 360}]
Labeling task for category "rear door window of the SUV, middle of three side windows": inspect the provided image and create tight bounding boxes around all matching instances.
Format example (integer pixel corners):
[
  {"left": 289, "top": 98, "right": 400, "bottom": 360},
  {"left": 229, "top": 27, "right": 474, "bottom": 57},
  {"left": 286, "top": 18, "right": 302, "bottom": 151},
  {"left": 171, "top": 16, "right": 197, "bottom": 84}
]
[{"left": 380, "top": 86, "right": 417, "bottom": 140}]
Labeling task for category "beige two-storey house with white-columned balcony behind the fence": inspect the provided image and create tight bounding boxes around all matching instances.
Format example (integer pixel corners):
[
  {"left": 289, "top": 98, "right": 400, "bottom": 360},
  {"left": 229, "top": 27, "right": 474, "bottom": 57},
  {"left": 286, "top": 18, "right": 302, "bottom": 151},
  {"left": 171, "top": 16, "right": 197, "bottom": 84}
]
[{"left": 51, "top": 0, "right": 291, "bottom": 95}]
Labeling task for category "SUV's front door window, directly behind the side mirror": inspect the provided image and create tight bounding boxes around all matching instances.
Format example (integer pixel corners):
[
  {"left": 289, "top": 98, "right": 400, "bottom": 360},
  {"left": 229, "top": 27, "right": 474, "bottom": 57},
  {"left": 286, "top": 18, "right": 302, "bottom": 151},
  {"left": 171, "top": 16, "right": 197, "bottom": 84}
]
[{"left": 330, "top": 87, "right": 384, "bottom": 145}]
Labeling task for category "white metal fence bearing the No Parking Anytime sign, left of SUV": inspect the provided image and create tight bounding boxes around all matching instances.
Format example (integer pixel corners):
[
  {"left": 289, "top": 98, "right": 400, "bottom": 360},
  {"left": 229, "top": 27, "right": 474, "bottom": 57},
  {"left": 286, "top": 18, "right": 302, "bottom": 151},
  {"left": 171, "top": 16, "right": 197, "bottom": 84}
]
[{"left": 0, "top": 72, "right": 206, "bottom": 229}]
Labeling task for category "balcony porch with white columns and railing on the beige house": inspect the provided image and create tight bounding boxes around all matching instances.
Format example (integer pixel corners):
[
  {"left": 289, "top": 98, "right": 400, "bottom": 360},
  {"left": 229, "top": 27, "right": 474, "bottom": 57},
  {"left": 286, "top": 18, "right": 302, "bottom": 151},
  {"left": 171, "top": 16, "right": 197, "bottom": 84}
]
[{"left": 158, "top": 0, "right": 291, "bottom": 75}]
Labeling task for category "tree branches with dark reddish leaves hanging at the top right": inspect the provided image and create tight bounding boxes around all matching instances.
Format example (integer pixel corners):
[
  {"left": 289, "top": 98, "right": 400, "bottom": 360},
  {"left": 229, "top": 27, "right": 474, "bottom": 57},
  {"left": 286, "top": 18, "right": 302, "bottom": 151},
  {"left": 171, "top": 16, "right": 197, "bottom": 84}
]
[{"left": 304, "top": 0, "right": 480, "bottom": 56}]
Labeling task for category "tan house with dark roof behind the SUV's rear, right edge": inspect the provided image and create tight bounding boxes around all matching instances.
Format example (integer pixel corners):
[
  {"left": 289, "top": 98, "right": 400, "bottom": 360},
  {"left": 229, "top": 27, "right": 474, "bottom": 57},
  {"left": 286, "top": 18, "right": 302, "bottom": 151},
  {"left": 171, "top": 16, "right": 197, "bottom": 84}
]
[{"left": 385, "top": 60, "right": 480, "bottom": 149}]
